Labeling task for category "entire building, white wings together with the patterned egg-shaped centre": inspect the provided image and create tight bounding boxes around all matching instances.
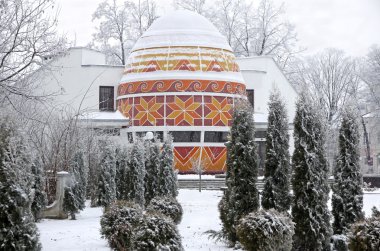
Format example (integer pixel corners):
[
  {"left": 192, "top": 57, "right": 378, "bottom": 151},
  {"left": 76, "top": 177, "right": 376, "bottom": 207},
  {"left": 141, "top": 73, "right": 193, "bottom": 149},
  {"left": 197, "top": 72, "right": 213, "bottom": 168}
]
[{"left": 40, "top": 11, "right": 297, "bottom": 173}]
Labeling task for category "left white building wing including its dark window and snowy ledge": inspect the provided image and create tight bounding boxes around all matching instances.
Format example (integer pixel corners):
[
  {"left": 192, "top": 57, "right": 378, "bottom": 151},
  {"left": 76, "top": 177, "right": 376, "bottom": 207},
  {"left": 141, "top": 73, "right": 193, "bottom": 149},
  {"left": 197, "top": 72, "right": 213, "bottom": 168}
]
[{"left": 41, "top": 47, "right": 128, "bottom": 134}]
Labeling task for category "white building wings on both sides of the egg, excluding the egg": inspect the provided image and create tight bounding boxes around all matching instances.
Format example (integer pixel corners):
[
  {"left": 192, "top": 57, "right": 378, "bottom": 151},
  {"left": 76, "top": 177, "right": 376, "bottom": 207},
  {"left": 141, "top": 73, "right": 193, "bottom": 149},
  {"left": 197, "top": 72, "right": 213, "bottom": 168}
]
[{"left": 43, "top": 47, "right": 297, "bottom": 174}]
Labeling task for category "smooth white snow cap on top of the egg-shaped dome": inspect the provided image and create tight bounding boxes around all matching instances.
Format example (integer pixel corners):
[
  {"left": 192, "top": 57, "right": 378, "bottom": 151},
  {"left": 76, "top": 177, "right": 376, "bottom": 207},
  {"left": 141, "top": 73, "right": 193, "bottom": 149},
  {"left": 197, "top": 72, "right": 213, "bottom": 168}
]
[{"left": 132, "top": 10, "right": 232, "bottom": 51}]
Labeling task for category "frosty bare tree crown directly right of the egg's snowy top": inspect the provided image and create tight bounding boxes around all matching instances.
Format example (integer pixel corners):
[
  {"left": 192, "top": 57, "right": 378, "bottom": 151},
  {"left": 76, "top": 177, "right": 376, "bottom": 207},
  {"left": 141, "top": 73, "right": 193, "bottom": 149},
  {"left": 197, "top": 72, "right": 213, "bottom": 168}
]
[{"left": 208, "top": 0, "right": 301, "bottom": 70}]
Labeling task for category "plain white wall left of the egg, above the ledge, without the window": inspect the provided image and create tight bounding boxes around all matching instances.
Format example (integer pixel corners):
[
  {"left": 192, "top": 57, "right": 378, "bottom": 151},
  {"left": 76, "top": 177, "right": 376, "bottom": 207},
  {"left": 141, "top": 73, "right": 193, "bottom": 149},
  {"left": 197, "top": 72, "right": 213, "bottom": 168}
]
[{"left": 42, "top": 48, "right": 124, "bottom": 111}]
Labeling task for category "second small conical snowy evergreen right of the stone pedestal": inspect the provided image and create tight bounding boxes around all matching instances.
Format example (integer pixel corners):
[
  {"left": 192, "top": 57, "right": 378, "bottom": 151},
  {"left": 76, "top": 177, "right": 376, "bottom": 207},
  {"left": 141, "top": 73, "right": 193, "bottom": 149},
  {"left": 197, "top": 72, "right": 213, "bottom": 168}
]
[{"left": 92, "top": 140, "right": 116, "bottom": 207}]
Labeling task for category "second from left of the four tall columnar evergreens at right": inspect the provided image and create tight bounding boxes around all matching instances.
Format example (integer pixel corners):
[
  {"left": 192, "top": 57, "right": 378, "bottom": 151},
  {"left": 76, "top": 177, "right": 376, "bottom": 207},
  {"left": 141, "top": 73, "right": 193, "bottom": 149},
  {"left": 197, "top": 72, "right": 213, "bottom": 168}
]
[{"left": 261, "top": 90, "right": 291, "bottom": 212}]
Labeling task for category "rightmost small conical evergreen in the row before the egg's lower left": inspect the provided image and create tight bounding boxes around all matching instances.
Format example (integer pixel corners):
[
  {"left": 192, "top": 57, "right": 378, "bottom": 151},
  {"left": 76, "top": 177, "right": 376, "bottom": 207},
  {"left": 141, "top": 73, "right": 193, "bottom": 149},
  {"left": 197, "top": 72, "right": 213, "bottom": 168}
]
[{"left": 156, "top": 135, "right": 178, "bottom": 198}]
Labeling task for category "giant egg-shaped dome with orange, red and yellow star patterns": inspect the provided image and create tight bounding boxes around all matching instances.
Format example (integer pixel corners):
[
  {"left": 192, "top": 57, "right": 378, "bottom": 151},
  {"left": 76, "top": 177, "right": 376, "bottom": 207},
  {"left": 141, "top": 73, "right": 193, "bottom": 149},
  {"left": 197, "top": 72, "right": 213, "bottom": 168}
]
[{"left": 117, "top": 11, "right": 245, "bottom": 173}]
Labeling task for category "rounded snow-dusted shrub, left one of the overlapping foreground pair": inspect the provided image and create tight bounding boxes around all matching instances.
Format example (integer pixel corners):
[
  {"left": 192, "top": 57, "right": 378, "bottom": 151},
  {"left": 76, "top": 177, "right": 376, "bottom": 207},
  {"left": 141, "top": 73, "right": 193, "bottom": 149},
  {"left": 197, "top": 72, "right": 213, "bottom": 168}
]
[{"left": 100, "top": 201, "right": 143, "bottom": 250}]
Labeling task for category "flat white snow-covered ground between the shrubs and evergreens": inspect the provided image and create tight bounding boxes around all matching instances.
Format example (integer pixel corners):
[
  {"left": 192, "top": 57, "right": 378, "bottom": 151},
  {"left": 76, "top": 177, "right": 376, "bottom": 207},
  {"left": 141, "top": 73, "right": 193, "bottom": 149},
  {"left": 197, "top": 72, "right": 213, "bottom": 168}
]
[{"left": 37, "top": 190, "right": 380, "bottom": 251}]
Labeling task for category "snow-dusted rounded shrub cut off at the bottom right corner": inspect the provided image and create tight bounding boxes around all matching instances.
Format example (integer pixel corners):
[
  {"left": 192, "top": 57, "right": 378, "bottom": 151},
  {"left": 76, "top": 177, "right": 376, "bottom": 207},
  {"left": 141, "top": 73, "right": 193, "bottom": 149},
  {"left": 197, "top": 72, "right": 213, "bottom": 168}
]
[{"left": 348, "top": 217, "right": 380, "bottom": 251}]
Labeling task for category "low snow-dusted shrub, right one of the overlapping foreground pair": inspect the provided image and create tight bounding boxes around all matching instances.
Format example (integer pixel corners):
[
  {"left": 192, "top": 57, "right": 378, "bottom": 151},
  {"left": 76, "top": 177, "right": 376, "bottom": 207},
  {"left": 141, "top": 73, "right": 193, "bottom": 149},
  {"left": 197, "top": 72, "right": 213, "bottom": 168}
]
[{"left": 132, "top": 213, "right": 184, "bottom": 251}]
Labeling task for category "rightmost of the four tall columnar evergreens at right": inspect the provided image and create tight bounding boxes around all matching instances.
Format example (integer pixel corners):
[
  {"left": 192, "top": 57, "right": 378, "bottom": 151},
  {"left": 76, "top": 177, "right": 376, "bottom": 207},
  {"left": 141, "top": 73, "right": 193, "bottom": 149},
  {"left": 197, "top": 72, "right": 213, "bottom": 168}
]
[{"left": 332, "top": 111, "right": 363, "bottom": 234}]
